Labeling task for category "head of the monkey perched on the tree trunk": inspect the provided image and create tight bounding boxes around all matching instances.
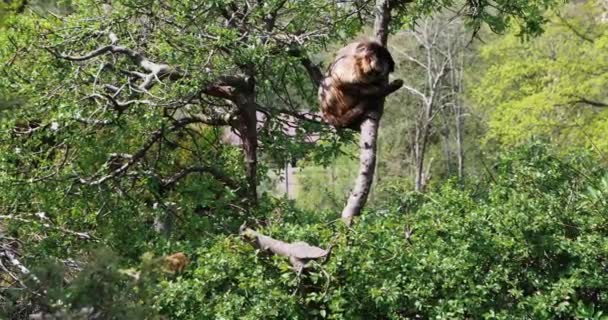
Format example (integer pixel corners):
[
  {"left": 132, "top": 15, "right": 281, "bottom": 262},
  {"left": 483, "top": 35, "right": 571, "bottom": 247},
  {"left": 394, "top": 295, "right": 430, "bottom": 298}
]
[{"left": 355, "top": 41, "right": 395, "bottom": 80}]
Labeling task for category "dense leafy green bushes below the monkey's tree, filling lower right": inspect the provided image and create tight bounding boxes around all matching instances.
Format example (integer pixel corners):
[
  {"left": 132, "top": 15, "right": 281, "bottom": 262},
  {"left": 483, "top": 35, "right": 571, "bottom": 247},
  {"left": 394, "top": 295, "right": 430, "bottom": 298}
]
[{"left": 25, "top": 145, "right": 608, "bottom": 319}]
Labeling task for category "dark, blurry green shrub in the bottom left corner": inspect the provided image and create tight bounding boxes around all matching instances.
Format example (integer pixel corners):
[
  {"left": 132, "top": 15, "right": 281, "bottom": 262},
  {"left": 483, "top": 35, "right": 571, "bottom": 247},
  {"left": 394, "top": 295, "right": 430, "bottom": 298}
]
[{"left": 1, "top": 248, "right": 162, "bottom": 320}]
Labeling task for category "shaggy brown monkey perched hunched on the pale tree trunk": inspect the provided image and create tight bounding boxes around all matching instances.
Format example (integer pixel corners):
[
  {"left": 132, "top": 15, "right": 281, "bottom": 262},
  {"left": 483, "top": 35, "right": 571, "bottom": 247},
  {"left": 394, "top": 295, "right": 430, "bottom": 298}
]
[{"left": 318, "top": 41, "right": 403, "bottom": 131}]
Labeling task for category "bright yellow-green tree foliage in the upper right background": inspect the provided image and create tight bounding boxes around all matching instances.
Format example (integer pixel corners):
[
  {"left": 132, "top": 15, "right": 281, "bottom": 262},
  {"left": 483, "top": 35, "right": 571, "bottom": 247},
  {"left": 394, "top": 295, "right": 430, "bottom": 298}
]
[{"left": 473, "top": 1, "right": 608, "bottom": 153}]
